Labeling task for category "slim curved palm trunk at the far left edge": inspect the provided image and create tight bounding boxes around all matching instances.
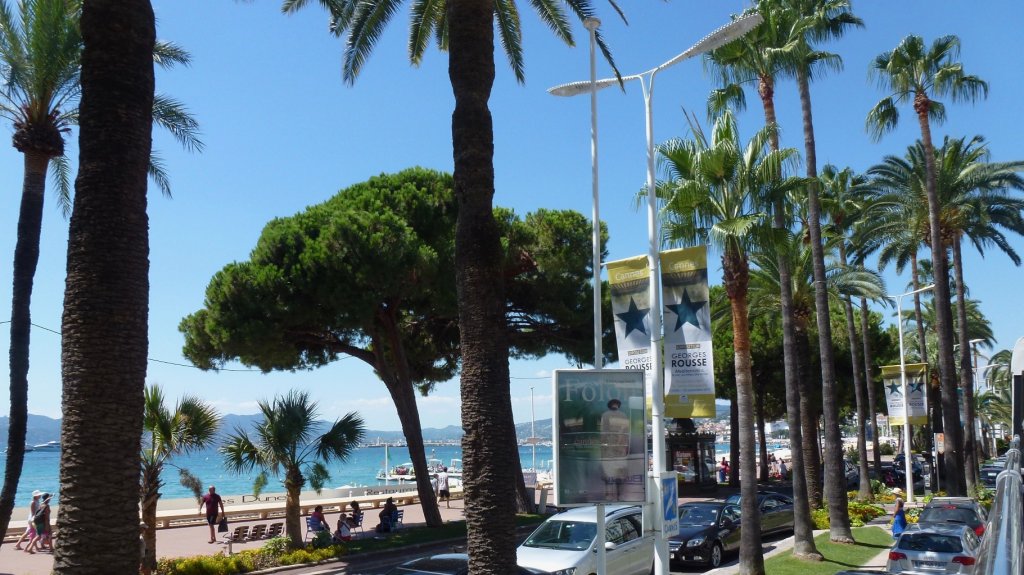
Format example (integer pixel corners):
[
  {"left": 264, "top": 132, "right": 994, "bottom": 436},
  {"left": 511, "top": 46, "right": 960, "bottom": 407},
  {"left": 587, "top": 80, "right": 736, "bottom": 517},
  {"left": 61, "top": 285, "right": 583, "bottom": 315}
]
[{"left": 0, "top": 152, "right": 49, "bottom": 544}]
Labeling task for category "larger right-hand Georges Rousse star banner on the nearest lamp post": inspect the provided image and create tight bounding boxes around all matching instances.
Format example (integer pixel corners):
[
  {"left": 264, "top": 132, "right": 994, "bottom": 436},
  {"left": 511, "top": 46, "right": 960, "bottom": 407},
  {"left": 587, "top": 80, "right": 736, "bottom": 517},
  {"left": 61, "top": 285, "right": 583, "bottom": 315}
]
[{"left": 662, "top": 246, "right": 715, "bottom": 417}]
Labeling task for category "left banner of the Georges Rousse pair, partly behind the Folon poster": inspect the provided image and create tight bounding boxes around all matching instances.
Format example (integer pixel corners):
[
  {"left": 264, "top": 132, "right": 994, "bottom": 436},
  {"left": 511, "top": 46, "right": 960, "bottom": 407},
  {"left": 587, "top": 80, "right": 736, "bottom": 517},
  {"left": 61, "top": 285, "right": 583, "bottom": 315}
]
[{"left": 606, "top": 256, "right": 651, "bottom": 380}]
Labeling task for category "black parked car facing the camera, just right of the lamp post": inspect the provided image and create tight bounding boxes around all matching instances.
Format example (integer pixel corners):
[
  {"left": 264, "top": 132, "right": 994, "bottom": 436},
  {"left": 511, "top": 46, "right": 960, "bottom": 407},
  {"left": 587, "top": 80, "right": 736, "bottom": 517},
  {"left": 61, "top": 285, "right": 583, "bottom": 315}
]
[{"left": 669, "top": 501, "right": 739, "bottom": 568}]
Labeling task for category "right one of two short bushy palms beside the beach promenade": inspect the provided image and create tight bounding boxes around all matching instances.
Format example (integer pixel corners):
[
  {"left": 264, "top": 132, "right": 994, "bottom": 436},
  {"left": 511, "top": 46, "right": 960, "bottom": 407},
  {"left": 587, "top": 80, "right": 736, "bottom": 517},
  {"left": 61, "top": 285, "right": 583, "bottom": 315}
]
[{"left": 220, "top": 391, "right": 364, "bottom": 547}]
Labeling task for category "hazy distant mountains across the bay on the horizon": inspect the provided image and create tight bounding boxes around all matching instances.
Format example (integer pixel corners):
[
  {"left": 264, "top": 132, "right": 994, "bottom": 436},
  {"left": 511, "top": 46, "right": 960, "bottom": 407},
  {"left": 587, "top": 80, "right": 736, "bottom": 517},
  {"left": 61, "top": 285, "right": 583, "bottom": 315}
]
[{"left": 0, "top": 413, "right": 551, "bottom": 451}]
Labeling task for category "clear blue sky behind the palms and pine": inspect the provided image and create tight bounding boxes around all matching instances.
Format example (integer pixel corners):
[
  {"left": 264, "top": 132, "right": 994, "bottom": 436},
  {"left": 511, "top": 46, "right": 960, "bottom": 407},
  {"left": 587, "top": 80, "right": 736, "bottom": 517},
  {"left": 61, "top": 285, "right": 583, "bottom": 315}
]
[{"left": 0, "top": 0, "right": 1024, "bottom": 429}]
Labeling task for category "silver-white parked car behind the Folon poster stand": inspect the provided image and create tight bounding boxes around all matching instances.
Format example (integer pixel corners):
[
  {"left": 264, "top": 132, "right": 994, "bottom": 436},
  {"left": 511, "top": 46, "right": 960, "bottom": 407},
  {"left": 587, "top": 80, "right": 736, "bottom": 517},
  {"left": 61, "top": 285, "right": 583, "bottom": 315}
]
[{"left": 516, "top": 505, "right": 654, "bottom": 575}]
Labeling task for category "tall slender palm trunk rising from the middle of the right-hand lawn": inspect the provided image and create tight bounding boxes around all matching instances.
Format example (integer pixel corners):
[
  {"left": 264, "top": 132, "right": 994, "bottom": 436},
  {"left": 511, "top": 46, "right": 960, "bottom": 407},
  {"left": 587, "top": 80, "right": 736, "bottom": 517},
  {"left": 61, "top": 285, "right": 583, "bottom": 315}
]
[{"left": 797, "top": 69, "right": 854, "bottom": 543}]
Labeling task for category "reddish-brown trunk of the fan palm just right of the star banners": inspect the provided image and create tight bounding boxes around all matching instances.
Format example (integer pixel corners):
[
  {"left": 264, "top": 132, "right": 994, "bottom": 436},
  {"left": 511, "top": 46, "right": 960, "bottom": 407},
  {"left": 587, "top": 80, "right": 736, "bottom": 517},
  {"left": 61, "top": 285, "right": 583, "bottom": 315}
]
[{"left": 722, "top": 248, "right": 765, "bottom": 575}]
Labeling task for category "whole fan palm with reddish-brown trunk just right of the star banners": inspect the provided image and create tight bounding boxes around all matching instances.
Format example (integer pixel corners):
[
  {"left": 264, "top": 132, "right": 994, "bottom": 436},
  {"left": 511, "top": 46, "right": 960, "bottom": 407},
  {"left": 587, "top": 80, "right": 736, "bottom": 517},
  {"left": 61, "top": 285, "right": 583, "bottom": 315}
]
[{"left": 656, "top": 110, "right": 800, "bottom": 574}]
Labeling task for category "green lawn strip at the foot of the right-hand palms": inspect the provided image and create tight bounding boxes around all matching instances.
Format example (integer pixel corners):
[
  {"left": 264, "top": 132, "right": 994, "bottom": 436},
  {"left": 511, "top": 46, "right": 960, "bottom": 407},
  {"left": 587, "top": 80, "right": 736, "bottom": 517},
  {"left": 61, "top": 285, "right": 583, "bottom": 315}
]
[{"left": 765, "top": 527, "right": 893, "bottom": 575}]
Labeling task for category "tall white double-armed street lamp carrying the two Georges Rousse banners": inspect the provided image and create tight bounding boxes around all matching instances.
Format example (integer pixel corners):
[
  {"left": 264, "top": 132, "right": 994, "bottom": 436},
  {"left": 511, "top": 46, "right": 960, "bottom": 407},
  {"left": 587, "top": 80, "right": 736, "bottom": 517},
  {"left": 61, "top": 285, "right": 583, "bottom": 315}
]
[{"left": 548, "top": 12, "right": 764, "bottom": 575}]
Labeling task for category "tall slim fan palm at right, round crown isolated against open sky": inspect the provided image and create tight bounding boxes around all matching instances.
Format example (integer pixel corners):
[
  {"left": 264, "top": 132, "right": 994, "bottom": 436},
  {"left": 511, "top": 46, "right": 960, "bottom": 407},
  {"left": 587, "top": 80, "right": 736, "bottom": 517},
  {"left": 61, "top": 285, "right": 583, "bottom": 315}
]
[{"left": 867, "top": 35, "right": 988, "bottom": 495}]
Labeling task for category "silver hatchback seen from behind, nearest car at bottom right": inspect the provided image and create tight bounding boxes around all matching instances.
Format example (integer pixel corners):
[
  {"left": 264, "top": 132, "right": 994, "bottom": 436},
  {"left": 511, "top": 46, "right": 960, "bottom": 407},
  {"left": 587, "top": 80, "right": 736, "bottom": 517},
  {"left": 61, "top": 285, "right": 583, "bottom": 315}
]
[{"left": 886, "top": 524, "right": 981, "bottom": 575}]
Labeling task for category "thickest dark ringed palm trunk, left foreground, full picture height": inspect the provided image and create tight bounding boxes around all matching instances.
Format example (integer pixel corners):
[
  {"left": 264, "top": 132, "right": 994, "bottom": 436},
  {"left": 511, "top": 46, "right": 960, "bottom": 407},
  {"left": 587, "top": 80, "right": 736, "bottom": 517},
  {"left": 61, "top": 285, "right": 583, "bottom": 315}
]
[{"left": 53, "top": 0, "right": 156, "bottom": 575}]
